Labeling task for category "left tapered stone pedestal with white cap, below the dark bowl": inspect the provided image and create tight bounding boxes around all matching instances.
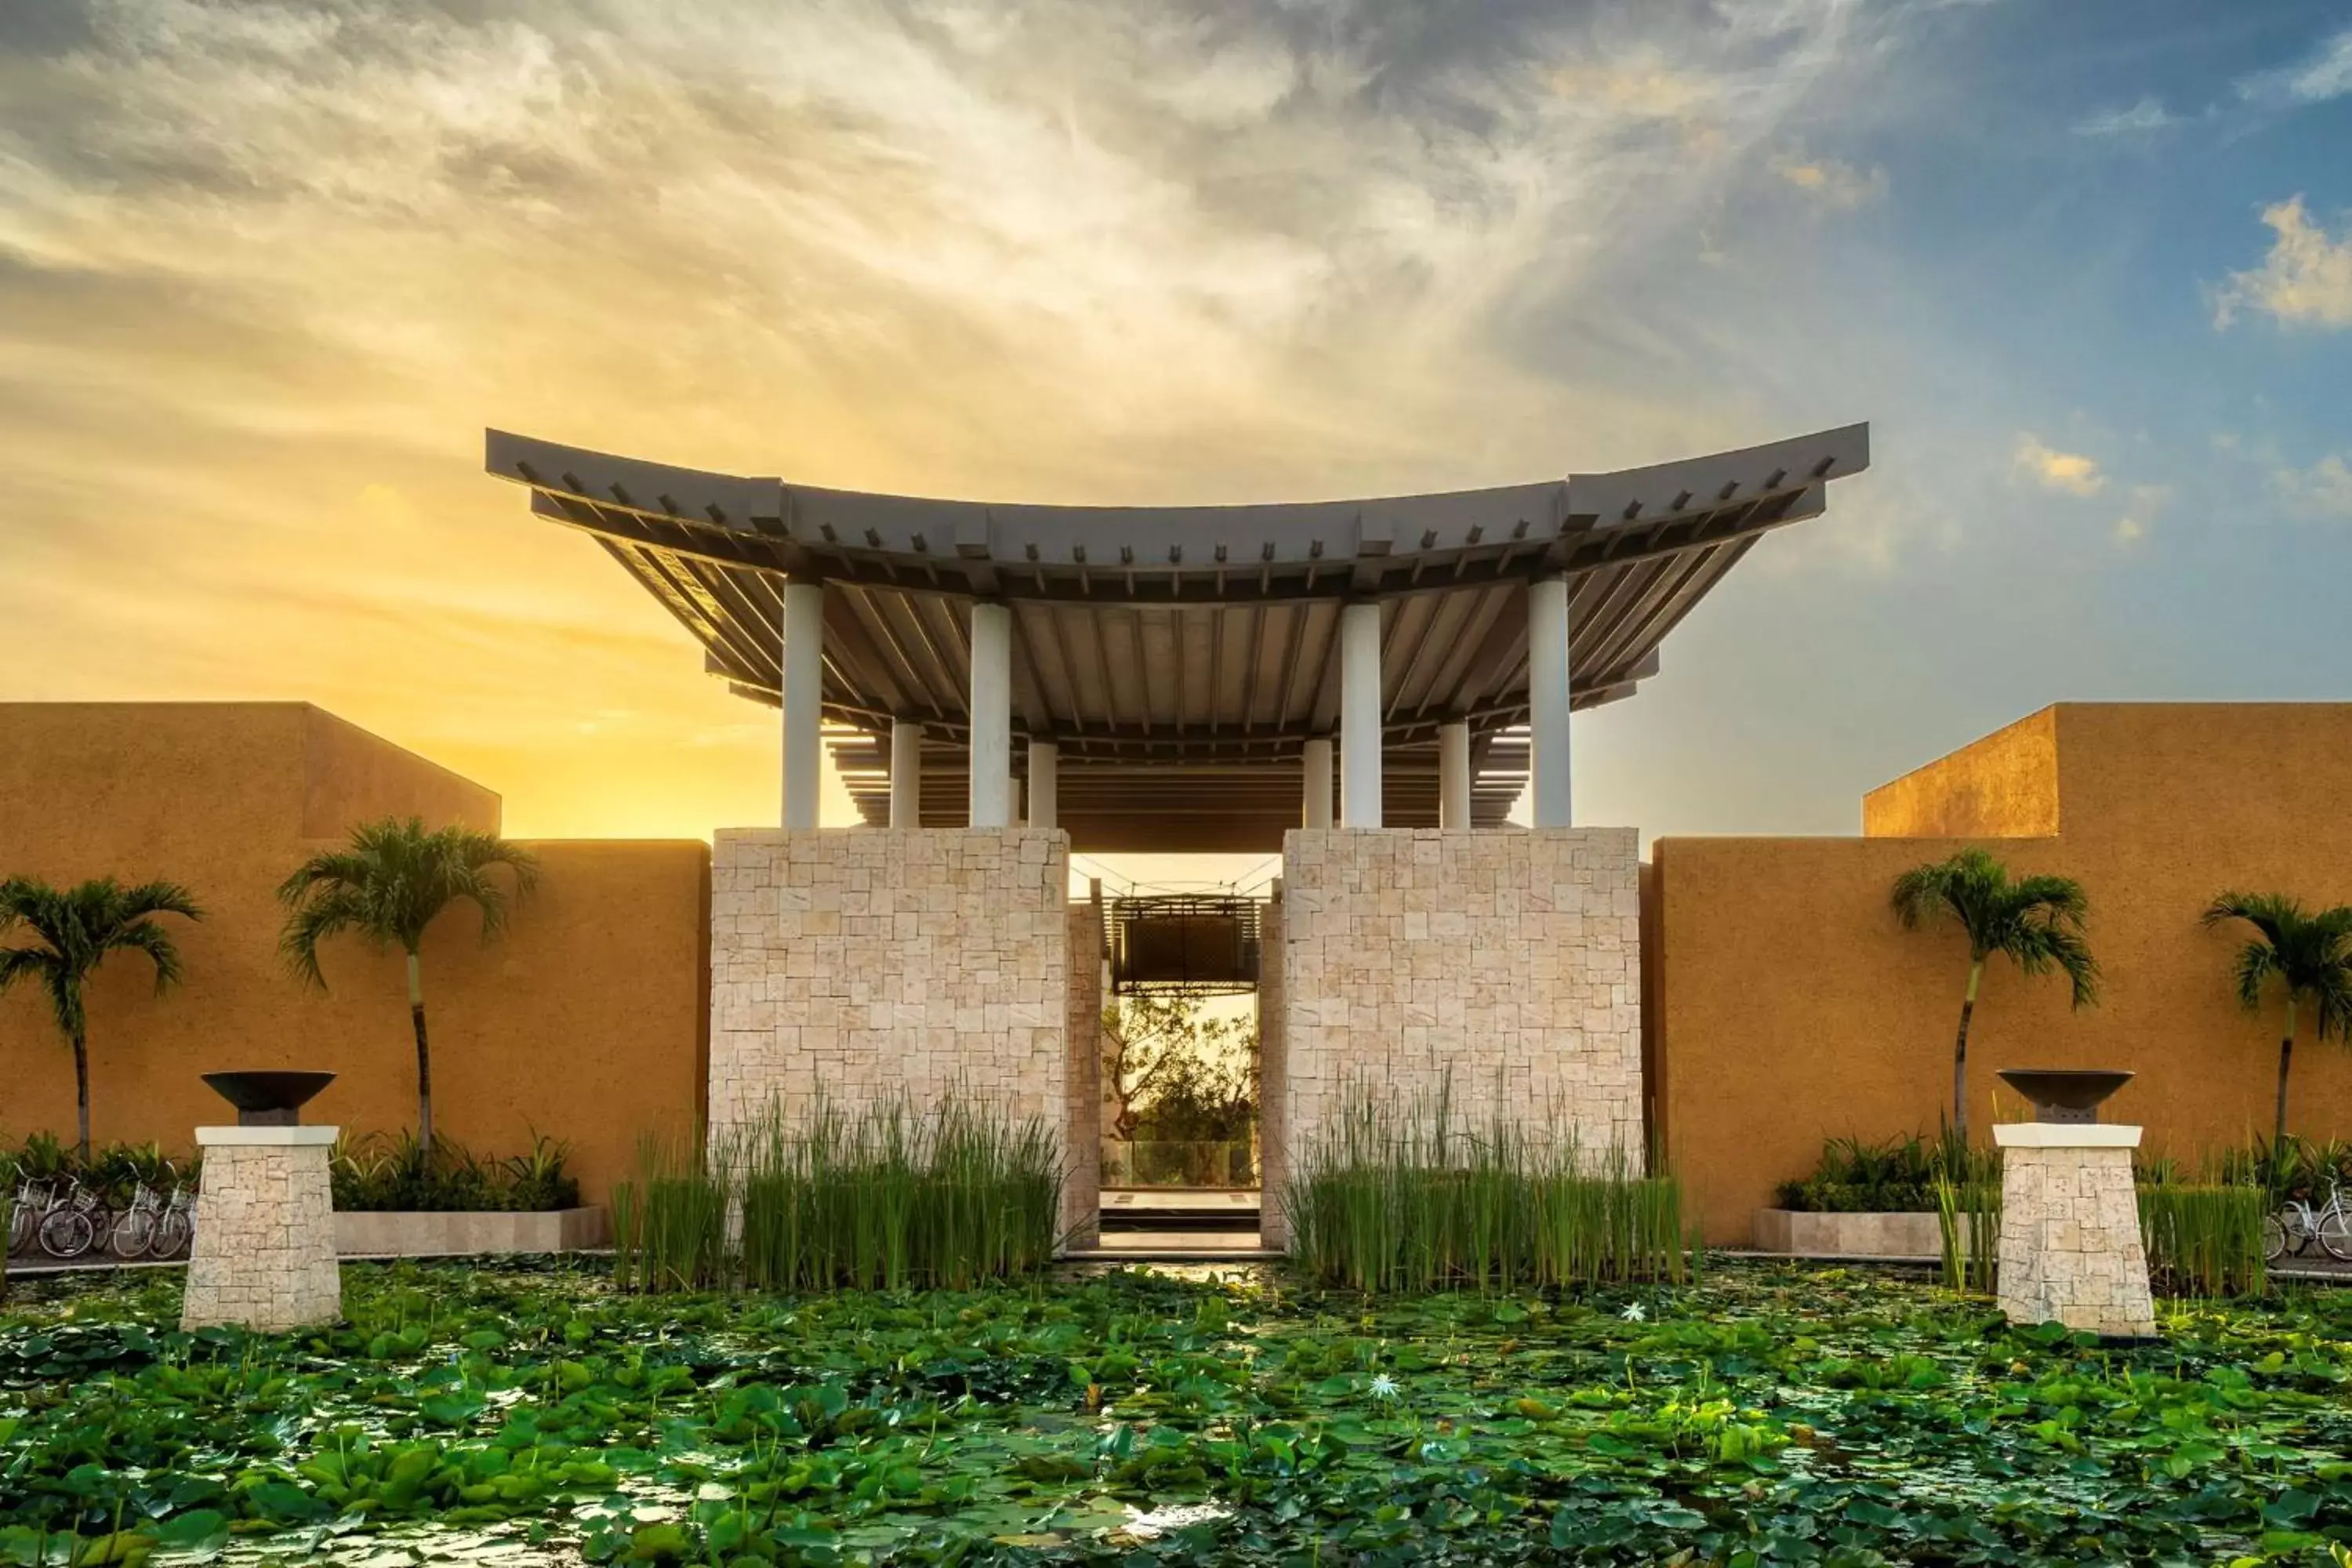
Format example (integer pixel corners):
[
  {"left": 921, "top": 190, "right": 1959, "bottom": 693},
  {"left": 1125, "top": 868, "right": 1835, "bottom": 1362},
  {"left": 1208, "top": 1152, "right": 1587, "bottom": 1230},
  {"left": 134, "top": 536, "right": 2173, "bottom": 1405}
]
[{"left": 179, "top": 1126, "right": 343, "bottom": 1330}]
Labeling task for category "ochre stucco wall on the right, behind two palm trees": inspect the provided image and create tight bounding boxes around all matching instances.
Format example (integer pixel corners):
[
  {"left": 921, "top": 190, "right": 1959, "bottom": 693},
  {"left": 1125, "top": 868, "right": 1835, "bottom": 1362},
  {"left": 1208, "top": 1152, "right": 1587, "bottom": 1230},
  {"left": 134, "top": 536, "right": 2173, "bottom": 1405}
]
[{"left": 1649, "top": 706, "right": 2352, "bottom": 1241}]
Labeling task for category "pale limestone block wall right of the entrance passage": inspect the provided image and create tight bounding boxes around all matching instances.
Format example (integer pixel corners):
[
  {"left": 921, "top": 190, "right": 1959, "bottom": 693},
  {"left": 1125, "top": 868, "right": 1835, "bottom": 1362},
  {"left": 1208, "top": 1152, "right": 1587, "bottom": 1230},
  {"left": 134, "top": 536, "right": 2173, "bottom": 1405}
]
[{"left": 1268, "top": 827, "right": 1644, "bottom": 1189}]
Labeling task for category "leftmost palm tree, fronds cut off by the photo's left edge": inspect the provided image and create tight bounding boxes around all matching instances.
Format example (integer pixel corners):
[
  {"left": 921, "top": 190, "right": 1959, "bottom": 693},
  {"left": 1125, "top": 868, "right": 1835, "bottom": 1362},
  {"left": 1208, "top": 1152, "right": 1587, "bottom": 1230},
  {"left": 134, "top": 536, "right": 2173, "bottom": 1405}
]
[{"left": 0, "top": 877, "right": 205, "bottom": 1168}]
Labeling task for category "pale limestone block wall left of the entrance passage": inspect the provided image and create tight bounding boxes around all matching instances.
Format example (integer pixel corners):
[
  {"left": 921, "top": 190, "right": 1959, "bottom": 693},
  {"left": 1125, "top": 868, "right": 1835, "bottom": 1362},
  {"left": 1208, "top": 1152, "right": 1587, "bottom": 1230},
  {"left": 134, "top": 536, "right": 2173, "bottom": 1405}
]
[{"left": 710, "top": 827, "right": 1070, "bottom": 1140}]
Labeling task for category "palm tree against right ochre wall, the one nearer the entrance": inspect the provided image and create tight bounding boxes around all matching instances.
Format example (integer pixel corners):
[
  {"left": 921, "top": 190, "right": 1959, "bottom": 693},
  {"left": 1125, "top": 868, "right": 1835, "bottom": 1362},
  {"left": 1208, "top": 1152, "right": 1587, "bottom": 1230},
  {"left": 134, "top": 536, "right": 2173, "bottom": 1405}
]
[{"left": 1893, "top": 848, "right": 2098, "bottom": 1140}]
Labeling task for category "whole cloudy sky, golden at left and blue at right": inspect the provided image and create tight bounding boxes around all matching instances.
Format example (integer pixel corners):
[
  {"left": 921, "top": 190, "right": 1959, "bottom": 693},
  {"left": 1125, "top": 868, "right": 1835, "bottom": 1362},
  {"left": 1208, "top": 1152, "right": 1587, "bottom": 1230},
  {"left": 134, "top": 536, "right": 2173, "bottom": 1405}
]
[{"left": 0, "top": 0, "right": 2352, "bottom": 874}]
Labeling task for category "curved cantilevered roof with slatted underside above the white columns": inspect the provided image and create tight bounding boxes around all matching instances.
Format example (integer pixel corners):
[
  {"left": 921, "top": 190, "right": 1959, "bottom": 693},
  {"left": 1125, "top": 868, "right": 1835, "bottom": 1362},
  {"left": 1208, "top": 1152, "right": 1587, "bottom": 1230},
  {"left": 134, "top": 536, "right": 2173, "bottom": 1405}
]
[{"left": 485, "top": 426, "right": 1870, "bottom": 851}]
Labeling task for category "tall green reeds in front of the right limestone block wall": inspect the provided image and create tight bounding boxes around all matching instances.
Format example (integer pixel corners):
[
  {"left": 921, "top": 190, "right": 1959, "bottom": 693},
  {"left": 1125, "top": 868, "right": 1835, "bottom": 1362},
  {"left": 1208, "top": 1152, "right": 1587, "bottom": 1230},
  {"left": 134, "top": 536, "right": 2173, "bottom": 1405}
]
[{"left": 1284, "top": 1088, "right": 1689, "bottom": 1290}]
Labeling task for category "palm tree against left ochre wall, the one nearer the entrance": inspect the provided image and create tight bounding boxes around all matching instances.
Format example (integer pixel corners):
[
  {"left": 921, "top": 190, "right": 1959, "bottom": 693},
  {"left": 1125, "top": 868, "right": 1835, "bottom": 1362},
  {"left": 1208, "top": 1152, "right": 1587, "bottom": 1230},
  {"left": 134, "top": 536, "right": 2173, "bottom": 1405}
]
[{"left": 278, "top": 815, "right": 539, "bottom": 1149}]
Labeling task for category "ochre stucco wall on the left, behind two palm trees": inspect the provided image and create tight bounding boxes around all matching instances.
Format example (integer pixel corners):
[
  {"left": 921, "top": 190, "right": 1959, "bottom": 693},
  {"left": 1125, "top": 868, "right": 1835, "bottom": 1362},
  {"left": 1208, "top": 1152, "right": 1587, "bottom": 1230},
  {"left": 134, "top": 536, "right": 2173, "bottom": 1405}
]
[{"left": 0, "top": 703, "right": 710, "bottom": 1201}]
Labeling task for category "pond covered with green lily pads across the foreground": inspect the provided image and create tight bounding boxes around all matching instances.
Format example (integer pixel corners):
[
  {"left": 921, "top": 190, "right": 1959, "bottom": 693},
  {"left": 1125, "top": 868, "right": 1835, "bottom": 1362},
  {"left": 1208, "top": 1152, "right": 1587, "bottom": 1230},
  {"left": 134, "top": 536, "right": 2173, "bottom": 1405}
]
[{"left": 0, "top": 1265, "right": 2352, "bottom": 1566}]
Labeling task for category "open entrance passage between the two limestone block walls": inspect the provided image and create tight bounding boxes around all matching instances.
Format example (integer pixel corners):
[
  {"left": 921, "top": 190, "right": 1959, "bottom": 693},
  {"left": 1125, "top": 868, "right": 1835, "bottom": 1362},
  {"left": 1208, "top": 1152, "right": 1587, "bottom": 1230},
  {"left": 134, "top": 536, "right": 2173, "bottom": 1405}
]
[{"left": 1098, "top": 893, "right": 1263, "bottom": 1246}]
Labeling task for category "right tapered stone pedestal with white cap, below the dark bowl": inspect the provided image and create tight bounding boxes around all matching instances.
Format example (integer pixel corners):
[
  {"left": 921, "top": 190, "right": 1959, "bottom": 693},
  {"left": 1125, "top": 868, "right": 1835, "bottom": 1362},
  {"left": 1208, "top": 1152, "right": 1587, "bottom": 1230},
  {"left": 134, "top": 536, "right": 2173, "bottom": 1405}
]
[{"left": 1992, "top": 1121, "right": 2157, "bottom": 1335}]
